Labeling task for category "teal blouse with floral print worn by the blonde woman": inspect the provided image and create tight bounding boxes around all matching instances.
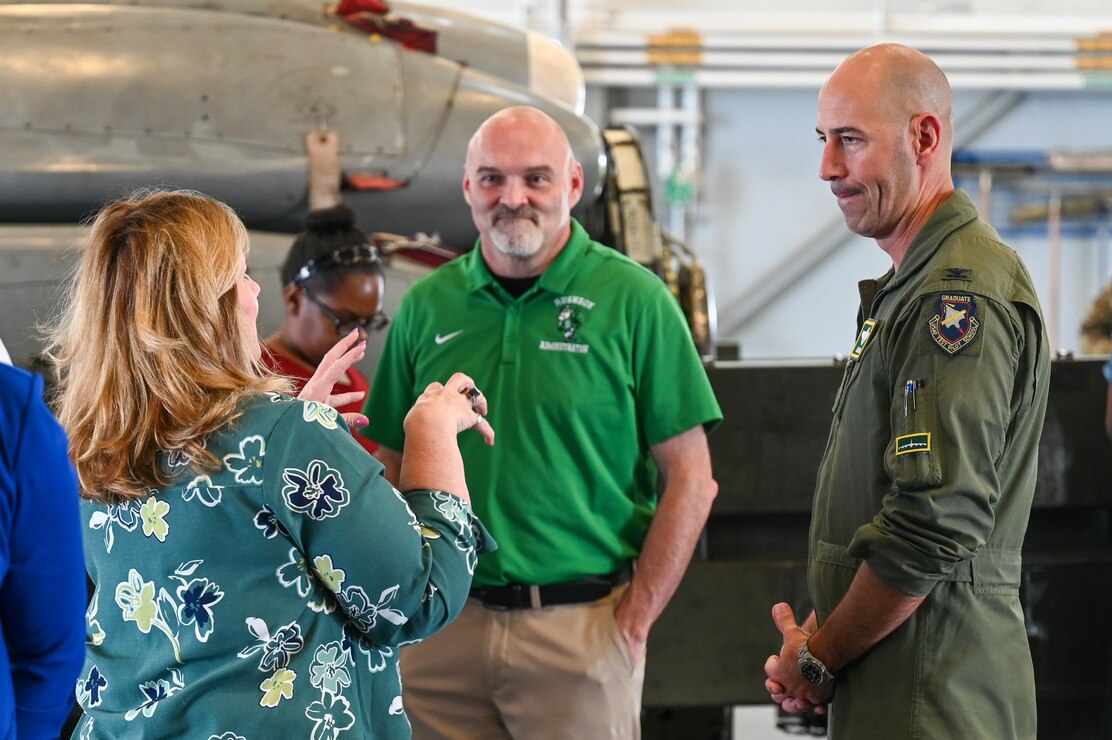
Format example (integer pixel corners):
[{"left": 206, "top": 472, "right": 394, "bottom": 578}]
[{"left": 77, "top": 395, "right": 494, "bottom": 740}]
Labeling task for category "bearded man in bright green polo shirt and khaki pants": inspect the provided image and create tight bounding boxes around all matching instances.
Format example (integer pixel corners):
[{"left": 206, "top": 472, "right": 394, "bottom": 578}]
[{"left": 355, "top": 108, "right": 722, "bottom": 740}]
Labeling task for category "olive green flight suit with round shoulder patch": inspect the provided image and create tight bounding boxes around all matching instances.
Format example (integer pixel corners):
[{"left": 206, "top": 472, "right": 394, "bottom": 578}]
[{"left": 808, "top": 191, "right": 1050, "bottom": 740}]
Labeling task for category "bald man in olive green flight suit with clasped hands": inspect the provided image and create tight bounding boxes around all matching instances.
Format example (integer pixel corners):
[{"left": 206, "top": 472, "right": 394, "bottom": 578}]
[{"left": 765, "top": 45, "right": 1050, "bottom": 740}]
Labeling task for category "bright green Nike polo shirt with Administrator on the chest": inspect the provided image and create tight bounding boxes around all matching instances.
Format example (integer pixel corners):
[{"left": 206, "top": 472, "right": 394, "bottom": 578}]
[{"left": 366, "top": 220, "right": 722, "bottom": 585}]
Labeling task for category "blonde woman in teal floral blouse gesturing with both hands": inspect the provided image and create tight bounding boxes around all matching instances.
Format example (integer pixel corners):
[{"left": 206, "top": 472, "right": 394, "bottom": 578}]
[{"left": 51, "top": 191, "right": 494, "bottom": 740}]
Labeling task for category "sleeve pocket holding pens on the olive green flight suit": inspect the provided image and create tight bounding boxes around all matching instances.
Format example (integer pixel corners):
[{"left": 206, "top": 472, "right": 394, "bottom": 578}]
[{"left": 884, "top": 378, "right": 942, "bottom": 491}]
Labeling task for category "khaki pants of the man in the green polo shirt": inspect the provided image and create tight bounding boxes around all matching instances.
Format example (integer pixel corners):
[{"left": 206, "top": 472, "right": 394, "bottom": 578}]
[{"left": 401, "top": 585, "right": 645, "bottom": 740}]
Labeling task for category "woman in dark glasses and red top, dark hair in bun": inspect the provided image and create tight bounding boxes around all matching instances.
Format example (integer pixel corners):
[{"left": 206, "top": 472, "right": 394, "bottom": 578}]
[{"left": 262, "top": 205, "right": 388, "bottom": 453}]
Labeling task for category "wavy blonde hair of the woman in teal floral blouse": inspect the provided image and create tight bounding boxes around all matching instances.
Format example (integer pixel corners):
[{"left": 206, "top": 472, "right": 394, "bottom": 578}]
[{"left": 48, "top": 190, "right": 288, "bottom": 503}]
